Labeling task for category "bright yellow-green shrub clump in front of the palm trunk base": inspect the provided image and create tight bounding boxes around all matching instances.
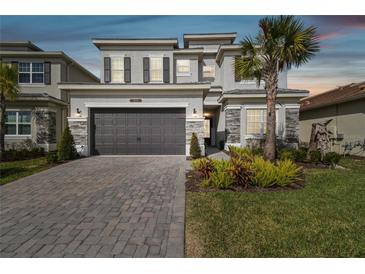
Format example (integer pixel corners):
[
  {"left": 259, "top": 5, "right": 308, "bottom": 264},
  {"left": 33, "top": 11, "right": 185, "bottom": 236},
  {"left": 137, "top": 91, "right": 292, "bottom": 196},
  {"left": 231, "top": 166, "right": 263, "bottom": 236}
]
[{"left": 251, "top": 156, "right": 300, "bottom": 188}]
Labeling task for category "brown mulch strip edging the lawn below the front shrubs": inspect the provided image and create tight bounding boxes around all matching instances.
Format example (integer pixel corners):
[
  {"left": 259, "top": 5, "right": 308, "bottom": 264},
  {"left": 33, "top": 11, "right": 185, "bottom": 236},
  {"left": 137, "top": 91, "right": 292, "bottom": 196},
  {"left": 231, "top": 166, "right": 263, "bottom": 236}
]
[{"left": 185, "top": 170, "right": 305, "bottom": 192}]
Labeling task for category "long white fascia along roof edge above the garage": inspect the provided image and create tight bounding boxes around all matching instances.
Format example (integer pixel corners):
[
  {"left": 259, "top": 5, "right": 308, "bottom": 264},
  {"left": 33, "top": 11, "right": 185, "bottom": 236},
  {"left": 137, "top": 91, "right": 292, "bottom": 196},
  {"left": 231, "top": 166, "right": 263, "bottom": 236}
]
[{"left": 58, "top": 84, "right": 210, "bottom": 91}]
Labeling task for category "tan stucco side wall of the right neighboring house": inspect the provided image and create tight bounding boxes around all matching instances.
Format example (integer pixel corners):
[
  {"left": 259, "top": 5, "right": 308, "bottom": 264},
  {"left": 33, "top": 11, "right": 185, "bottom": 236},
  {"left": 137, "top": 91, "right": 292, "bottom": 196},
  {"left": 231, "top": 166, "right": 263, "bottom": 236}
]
[{"left": 299, "top": 99, "right": 365, "bottom": 156}]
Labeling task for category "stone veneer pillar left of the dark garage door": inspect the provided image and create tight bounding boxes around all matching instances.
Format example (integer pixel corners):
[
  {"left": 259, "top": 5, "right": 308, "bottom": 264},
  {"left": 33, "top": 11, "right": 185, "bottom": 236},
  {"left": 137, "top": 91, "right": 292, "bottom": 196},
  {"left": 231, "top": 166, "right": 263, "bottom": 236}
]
[{"left": 68, "top": 118, "right": 88, "bottom": 156}]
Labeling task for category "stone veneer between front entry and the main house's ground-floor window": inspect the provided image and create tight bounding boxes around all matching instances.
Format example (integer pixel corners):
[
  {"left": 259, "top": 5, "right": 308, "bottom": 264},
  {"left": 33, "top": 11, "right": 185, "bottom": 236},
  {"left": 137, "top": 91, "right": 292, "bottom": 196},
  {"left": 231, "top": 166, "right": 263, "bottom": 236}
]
[{"left": 225, "top": 109, "right": 241, "bottom": 144}]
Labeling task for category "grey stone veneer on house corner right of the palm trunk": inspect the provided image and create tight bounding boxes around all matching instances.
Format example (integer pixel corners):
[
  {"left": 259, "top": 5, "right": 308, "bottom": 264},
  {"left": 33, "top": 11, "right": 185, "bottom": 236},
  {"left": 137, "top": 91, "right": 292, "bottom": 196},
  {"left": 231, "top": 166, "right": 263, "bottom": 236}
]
[{"left": 285, "top": 108, "right": 299, "bottom": 147}]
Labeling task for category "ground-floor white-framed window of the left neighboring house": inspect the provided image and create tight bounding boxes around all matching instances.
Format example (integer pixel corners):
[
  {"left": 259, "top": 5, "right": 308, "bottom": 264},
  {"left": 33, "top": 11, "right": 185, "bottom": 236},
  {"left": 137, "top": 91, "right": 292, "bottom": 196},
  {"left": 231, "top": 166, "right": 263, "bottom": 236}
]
[{"left": 5, "top": 111, "right": 32, "bottom": 135}]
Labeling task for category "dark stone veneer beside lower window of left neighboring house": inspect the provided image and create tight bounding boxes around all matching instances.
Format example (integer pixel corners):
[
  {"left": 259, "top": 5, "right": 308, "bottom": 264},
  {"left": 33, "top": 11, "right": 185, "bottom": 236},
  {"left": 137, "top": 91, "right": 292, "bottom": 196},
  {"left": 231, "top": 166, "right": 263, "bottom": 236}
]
[{"left": 33, "top": 110, "right": 57, "bottom": 145}]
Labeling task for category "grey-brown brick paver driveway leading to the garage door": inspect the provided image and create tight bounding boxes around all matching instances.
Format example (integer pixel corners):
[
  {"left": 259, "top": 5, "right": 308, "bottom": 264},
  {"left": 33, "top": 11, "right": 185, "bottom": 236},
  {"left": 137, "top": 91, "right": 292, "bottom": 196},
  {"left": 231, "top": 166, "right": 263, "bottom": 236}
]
[{"left": 0, "top": 156, "right": 186, "bottom": 257}]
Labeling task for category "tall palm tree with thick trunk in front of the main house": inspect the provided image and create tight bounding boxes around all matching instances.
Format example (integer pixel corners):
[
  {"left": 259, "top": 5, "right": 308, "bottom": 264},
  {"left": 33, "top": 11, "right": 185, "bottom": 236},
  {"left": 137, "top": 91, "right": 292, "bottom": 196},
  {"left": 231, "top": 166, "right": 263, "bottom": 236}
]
[{"left": 234, "top": 16, "right": 319, "bottom": 160}]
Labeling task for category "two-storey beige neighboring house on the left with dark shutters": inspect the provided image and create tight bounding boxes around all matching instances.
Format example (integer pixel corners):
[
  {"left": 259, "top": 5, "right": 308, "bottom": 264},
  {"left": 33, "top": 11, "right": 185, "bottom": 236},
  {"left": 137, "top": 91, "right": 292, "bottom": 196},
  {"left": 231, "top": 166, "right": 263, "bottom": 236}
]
[{"left": 0, "top": 41, "right": 99, "bottom": 151}]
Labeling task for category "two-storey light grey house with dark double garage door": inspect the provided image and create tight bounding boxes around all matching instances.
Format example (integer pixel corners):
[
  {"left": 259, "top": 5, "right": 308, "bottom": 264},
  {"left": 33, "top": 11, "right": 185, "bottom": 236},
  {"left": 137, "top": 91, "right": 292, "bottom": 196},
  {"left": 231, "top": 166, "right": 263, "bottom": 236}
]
[{"left": 58, "top": 33, "right": 309, "bottom": 155}]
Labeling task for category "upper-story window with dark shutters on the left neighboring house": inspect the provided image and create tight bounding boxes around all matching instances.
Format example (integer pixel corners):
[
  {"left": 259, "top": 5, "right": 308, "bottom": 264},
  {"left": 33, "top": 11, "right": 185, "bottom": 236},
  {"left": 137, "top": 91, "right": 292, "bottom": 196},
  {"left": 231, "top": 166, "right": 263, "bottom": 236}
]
[{"left": 18, "top": 62, "right": 44, "bottom": 84}]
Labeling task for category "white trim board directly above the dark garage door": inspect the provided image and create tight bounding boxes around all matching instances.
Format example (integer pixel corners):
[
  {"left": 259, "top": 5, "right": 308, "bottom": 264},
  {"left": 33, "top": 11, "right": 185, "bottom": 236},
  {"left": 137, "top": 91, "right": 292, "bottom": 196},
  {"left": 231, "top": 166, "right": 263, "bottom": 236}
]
[{"left": 84, "top": 102, "right": 189, "bottom": 108}]
